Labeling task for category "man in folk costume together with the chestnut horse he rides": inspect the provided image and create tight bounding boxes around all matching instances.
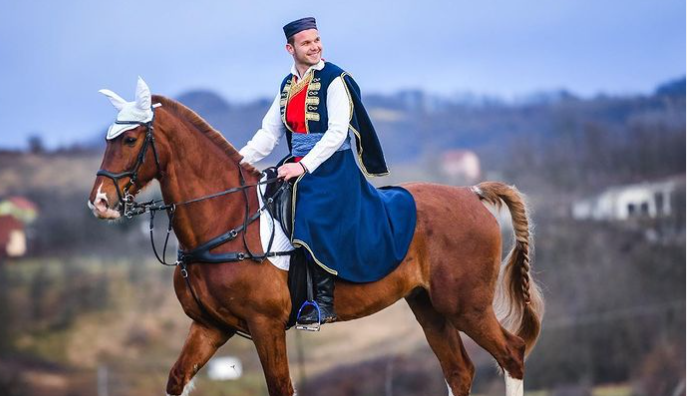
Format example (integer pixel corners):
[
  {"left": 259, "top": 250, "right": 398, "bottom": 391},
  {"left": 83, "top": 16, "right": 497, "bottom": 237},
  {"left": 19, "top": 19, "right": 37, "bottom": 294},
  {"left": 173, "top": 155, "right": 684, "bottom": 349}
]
[{"left": 88, "top": 19, "right": 544, "bottom": 396}]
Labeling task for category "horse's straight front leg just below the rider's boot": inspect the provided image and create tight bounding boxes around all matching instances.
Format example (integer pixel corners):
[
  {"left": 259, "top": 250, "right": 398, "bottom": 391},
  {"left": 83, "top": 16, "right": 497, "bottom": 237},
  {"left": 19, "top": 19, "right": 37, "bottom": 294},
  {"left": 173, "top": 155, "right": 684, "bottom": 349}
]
[{"left": 248, "top": 317, "right": 295, "bottom": 396}]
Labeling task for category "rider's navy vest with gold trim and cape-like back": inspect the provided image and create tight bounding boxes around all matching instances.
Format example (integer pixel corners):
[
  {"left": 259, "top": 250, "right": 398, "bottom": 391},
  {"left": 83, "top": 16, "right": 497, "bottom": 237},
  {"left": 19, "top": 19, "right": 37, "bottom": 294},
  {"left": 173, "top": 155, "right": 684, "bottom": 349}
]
[{"left": 279, "top": 62, "right": 389, "bottom": 176}]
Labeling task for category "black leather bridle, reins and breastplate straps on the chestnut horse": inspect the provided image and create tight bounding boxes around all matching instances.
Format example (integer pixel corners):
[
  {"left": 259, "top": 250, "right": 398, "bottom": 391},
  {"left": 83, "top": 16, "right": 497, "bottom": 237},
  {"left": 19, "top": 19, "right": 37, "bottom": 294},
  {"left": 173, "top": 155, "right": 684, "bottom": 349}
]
[{"left": 96, "top": 108, "right": 294, "bottom": 338}]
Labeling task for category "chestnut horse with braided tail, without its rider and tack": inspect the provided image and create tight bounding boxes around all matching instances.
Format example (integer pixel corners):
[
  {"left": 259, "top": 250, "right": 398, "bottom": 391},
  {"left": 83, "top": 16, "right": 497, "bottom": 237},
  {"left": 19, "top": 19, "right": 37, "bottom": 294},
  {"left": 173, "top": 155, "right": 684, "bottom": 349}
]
[{"left": 89, "top": 95, "right": 543, "bottom": 396}]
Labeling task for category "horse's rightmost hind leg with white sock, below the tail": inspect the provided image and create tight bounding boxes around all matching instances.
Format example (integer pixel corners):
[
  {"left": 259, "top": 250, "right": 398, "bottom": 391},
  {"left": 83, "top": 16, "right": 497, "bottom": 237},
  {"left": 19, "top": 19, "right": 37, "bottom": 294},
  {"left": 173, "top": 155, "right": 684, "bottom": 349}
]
[{"left": 452, "top": 310, "right": 525, "bottom": 396}]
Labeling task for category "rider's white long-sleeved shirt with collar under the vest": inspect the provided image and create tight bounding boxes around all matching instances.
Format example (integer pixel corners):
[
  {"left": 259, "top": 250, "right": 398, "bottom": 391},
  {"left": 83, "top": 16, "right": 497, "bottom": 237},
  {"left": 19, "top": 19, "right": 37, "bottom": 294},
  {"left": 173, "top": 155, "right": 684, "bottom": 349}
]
[{"left": 239, "top": 60, "right": 351, "bottom": 172}]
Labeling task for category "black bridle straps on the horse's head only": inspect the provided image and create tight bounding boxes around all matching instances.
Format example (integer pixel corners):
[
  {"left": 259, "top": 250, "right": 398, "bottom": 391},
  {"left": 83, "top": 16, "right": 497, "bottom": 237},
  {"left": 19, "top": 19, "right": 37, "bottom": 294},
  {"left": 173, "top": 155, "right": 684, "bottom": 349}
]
[{"left": 96, "top": 107, "right": 162, "bottom": 219}]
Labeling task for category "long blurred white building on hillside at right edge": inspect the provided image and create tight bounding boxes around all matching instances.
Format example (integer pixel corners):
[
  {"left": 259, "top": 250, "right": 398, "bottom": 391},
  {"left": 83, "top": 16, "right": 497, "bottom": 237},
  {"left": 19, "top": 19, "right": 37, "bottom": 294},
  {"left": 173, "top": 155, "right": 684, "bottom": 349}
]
[{"left": 572, "top": 175, "right": 685, "bottom": 220}]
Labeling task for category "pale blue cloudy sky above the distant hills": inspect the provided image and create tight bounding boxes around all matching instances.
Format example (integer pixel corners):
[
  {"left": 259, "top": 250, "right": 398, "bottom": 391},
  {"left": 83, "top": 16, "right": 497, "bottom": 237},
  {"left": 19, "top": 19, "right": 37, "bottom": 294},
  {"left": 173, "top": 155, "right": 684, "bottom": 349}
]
[{"left": 0, "top": 0, "right": 686, "bottom": 148}]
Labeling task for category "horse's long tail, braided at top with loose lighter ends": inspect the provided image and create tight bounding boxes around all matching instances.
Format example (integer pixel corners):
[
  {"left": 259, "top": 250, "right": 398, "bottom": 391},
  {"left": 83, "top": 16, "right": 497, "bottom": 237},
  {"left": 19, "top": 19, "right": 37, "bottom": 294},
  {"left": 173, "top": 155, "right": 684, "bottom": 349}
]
[{"left": 472, "top": 182, "right": 544, "bottom": 356}]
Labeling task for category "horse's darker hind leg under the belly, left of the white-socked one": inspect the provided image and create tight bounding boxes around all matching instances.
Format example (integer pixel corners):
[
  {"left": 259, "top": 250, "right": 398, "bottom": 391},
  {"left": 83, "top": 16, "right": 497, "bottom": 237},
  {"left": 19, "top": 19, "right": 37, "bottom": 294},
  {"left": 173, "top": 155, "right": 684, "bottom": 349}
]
[{"left": 406, "top": 290, "right": 475, "bottom": 396}]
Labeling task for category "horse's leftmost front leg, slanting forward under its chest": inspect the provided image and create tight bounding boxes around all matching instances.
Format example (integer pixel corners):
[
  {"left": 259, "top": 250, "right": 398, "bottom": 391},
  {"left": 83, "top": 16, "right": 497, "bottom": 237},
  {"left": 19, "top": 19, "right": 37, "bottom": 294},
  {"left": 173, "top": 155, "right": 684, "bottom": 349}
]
[{"left": 167, "top": 321, "right": 234, "bottom": 396}]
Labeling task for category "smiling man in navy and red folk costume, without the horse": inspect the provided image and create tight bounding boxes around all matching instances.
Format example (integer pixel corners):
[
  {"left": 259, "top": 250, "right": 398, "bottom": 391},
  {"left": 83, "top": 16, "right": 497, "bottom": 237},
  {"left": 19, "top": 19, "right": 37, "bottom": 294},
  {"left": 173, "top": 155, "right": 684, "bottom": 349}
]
[{"left": 240, "top": 18, "right": 416, "bottom": 324}]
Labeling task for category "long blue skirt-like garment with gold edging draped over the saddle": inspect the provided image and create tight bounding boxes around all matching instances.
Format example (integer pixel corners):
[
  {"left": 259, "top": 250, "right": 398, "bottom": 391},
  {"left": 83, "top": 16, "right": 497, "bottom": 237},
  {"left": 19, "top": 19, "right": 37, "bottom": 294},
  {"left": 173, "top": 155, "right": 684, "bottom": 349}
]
[{"left": 291, "top": 150, "right": 417, "bottom": 283}]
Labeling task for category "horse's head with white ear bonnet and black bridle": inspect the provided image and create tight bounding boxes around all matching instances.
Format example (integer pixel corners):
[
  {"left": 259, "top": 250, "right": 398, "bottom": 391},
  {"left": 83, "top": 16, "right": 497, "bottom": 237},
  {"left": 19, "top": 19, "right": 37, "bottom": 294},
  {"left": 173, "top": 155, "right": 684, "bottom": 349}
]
[{"left": 88, "top": 77, "right": 160, "bottom": 220}]
